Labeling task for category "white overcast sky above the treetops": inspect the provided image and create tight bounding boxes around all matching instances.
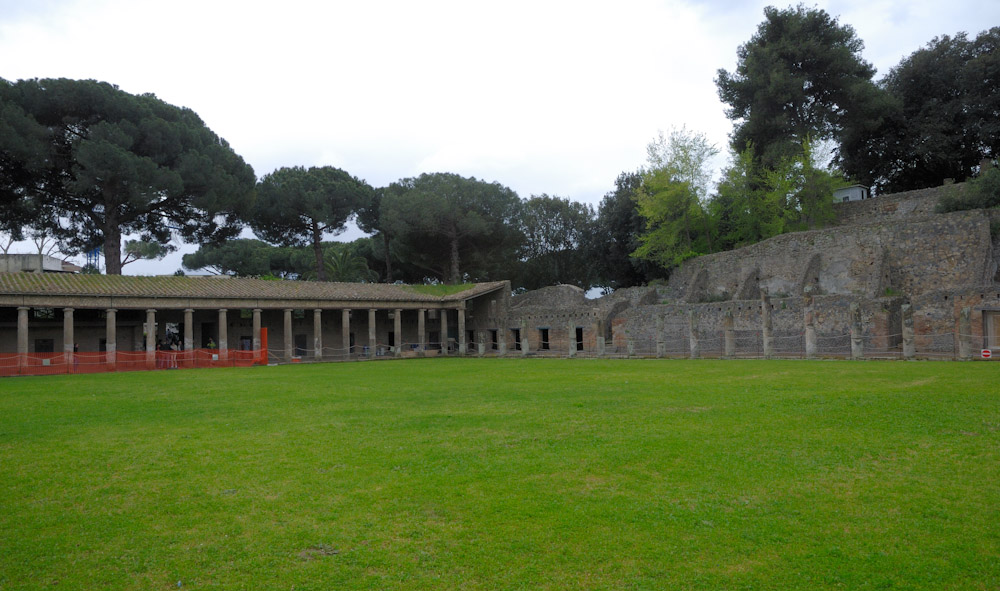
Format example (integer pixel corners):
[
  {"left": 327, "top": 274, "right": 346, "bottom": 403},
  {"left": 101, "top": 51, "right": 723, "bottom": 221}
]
[{"left": 0, "top": 0, "right": 1000, "bottom": 274}]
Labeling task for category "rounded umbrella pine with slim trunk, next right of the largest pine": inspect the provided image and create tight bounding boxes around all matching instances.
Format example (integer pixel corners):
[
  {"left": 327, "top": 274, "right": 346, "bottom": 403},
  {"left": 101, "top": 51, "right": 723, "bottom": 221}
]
[{"left": 250, "top": 166, "right": 373, "bottom": 281}]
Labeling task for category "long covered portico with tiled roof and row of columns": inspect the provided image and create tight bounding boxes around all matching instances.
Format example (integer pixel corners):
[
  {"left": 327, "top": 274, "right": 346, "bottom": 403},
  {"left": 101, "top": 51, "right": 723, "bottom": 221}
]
[{"left": 0, "top": 273, "right": 510, "bottom": 374}]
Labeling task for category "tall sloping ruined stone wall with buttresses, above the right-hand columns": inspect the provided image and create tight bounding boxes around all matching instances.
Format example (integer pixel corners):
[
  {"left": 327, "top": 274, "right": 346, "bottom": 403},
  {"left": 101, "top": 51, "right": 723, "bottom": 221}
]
[{"left": 665, "top": 210, "right": 996, "bottom": 303}]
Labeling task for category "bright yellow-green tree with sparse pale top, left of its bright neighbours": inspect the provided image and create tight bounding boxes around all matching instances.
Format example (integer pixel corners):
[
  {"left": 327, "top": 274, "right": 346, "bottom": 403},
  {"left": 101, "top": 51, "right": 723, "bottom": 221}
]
[{"left": 634, "top": 129, "right": 717, "bottom": 268}]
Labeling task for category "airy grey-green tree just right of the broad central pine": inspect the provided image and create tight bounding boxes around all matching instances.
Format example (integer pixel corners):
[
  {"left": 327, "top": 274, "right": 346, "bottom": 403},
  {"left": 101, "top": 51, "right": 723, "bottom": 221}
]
[{"left": 512, "top": 194, "right": 594, "bottom": 289}]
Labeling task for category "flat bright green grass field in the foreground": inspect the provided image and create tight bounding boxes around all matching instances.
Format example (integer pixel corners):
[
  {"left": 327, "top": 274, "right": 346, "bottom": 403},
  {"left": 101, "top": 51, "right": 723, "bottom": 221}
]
[{"left": 0, "top": 359, "right": 1000, "bottom": 591}]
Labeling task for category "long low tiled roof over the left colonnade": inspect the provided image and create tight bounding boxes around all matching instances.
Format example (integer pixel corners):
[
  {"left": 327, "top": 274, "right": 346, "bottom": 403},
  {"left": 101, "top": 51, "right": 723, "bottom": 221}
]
[{"left": 0, "top": 273, "right": 505, "bottom": 302}]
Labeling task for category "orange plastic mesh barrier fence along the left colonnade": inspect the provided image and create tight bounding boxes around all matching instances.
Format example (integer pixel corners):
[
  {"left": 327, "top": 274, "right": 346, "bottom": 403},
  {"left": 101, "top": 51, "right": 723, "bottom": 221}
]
[{"left": 0, "top": 349, "right": 267, "bottom": 377}]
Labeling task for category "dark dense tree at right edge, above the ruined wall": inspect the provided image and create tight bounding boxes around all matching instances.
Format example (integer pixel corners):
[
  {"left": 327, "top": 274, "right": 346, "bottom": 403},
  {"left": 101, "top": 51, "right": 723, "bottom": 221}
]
[{"left": 841, "top": 27, "right": 1000, "bottom": 193}]
